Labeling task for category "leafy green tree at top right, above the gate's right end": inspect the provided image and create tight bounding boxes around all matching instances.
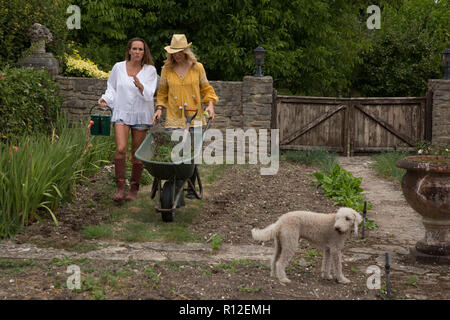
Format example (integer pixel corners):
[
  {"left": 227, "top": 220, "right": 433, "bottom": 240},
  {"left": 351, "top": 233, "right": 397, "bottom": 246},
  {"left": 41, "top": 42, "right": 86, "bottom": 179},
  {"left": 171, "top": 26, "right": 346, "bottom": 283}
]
[{"left": 354, "top": 0, "right": 450, "bottom": 96}]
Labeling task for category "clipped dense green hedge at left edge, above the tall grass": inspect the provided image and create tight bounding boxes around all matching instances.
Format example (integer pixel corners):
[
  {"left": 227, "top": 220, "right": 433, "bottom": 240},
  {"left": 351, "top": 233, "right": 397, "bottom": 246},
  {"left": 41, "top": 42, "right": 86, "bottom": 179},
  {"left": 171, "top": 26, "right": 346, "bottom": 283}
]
[{"left": 0, "top": 67, "right": 63, "bottom": 142}]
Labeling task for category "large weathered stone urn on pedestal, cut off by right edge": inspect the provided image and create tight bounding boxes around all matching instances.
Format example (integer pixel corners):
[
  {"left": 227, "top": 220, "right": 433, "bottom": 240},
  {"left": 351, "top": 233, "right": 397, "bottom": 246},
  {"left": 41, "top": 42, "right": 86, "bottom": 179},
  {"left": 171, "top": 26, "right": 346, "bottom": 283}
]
[{"left": 396, "top": 155, "right": 450, "bottom": 264}]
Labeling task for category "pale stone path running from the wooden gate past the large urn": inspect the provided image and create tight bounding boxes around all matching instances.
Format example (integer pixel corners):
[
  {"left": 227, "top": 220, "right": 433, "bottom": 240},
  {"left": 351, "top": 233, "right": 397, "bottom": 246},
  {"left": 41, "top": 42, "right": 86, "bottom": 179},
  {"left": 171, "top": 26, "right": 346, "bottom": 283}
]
[{"left": 338, "top": 157, "right": 425, "bottom": 247}]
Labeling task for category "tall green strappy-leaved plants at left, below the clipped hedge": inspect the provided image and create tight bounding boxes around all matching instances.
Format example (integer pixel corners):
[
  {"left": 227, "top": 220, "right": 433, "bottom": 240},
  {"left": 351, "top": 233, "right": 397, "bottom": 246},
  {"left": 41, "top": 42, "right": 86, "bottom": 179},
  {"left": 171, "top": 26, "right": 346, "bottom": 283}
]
[{"left": 0, "top": 116, "right": 114, "bottom": 238}]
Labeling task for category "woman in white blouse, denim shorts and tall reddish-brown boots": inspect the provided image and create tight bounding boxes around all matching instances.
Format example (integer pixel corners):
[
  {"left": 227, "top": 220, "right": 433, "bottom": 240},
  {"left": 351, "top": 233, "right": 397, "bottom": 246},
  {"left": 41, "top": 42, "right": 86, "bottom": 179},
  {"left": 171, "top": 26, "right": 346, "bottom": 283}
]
[{"left": 98, "top": 38, "right": 157, "bottom": 201}]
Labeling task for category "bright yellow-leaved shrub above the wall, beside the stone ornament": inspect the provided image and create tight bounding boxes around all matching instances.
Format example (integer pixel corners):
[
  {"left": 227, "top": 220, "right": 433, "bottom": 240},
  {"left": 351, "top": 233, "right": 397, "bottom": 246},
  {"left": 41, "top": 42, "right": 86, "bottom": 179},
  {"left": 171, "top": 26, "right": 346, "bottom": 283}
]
[{"left": 63, "top": 50, "right": 109, "bottom": 78}]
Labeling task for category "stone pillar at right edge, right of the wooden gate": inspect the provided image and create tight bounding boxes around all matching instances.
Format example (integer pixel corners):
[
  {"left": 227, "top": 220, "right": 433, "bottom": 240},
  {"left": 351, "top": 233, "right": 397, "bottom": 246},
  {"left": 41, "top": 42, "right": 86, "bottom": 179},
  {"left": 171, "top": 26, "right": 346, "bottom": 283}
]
[{"left": 428, "top": 79, "right": 450, "bottom": 143}]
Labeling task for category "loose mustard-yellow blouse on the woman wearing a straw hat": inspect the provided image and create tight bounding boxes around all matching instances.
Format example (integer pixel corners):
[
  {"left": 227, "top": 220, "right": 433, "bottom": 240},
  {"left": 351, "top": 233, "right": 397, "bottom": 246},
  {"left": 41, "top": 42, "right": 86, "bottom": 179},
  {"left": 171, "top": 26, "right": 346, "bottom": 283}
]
[{"left": 156, "top": 62, "right": 219, "bottom": 128}]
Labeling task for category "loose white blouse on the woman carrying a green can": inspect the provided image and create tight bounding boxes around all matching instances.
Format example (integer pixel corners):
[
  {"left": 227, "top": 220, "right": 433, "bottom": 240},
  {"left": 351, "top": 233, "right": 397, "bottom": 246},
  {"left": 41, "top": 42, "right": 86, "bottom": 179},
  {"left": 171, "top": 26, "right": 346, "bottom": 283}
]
[{"left": 102, "top": 61, "right": 158, "bottom": 125}]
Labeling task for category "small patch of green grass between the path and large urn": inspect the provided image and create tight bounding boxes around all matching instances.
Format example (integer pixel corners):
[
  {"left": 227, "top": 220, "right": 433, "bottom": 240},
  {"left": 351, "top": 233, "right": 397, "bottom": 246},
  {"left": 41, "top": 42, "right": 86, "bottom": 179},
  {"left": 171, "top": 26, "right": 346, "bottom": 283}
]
[{"left": 372, "top": 152, "right": 410, "bottom": 182}]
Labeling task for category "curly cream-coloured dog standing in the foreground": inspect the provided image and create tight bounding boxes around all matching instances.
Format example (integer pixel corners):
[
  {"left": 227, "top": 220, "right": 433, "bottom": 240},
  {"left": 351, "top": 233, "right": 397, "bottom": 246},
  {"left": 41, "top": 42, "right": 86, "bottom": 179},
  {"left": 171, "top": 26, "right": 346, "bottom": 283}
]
[{"left": 252, "top": 208, "right": 362, "bottom": 283}]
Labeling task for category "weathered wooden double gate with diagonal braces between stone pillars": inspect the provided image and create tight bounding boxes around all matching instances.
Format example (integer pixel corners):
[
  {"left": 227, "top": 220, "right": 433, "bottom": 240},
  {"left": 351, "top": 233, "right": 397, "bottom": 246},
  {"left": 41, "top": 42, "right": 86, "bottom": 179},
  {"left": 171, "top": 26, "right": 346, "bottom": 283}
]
[{"left": 273, "top": 96, "right": 429, "bottom": 155}]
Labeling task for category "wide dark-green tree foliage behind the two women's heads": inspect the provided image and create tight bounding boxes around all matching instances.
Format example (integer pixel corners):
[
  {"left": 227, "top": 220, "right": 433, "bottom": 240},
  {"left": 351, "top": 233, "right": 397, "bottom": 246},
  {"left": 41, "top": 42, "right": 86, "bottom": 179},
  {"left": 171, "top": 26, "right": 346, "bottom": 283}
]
[{"left": 66, "top": 0, "right": 366, "bottom": 94}]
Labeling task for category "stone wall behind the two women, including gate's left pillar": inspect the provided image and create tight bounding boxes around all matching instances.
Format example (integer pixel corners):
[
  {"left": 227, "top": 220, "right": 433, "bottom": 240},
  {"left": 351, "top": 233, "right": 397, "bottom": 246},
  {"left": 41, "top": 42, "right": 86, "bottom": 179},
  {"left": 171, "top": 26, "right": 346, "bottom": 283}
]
[{"left": 56, "top": 76, "right": 273, "bottom": 130}]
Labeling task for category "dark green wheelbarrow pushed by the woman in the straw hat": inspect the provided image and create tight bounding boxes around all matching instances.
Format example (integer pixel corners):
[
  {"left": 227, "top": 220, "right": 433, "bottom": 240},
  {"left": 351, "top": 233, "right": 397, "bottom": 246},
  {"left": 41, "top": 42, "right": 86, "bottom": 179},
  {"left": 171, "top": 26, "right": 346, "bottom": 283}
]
[{"left": 135, "top": 105, "right": 210, "bottom": 222}]
